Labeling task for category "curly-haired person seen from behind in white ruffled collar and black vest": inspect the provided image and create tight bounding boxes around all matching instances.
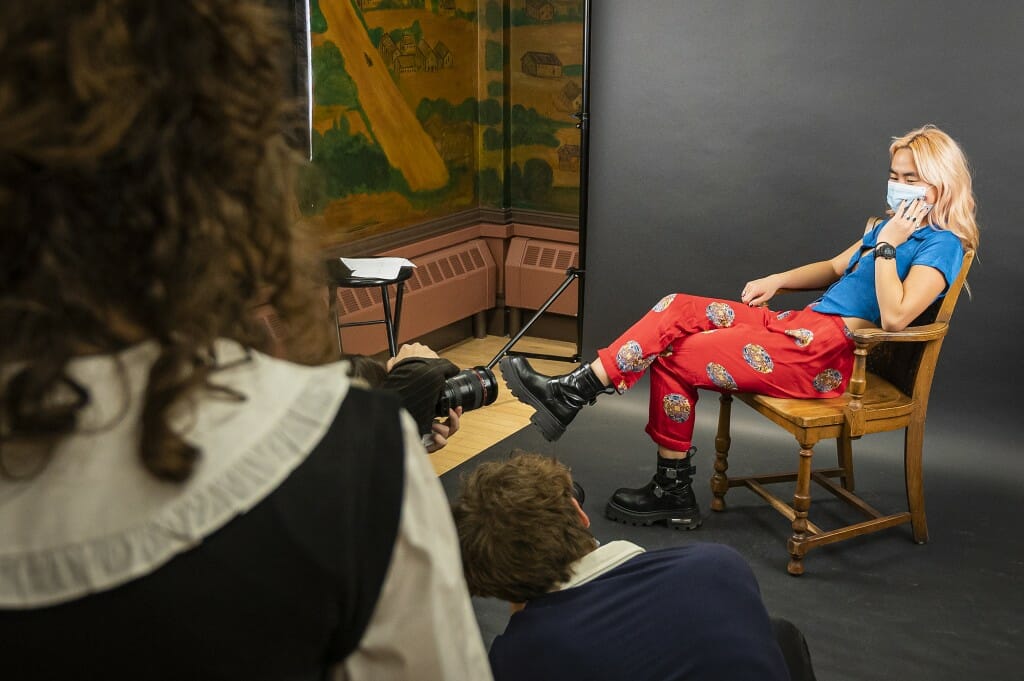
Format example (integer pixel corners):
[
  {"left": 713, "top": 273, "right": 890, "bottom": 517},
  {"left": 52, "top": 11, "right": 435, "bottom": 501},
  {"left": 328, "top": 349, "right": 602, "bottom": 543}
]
[{"left": 0, "top": 0, "right": 490, "bottom": 681}]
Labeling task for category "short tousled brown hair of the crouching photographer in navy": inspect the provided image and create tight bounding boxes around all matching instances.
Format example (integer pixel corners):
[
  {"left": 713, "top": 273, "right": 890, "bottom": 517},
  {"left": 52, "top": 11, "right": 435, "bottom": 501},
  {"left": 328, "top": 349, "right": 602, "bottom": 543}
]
[{"left": 452, "top": 452, "right": 597, "bottom": 603}]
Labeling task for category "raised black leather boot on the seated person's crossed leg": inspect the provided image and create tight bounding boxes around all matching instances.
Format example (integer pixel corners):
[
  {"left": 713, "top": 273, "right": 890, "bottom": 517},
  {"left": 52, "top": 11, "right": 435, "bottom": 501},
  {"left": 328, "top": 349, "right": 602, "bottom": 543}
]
[{"left": 498, "top": 355, "right": 614, "bottom": 441}]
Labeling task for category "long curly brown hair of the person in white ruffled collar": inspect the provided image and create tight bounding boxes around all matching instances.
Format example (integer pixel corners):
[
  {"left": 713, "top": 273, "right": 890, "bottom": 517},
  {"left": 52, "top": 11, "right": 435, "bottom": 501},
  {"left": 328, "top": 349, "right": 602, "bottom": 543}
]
[{"left": 0, "top": 0, "right": 327, "bottom": 480}]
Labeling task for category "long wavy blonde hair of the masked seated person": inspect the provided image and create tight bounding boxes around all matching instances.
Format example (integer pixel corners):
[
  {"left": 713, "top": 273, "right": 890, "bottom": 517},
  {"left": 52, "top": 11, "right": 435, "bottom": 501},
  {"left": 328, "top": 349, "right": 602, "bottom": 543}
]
[{"left": 889, "top": 124, "right": 978, "bottom": 249}]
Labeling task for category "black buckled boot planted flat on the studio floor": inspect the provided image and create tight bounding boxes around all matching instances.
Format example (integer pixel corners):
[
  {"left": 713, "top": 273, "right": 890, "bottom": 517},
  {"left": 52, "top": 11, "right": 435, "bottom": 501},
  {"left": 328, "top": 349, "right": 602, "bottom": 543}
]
[{"left": 604, "top": 448, "right": 701, "bottom": 529}]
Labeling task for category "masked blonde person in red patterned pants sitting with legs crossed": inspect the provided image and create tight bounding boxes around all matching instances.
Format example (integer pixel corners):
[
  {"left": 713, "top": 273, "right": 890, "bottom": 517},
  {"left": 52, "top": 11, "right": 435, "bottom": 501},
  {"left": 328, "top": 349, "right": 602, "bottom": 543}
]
[{"left": 500, "top": 125, "right": 978, "bottom": 529}]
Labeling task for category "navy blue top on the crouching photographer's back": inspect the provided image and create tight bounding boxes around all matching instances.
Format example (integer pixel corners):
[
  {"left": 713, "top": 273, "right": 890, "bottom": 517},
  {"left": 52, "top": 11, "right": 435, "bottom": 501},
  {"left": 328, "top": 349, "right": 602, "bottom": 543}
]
[{"left": 490, "top": 544, "right": 790, "bottom": 681}]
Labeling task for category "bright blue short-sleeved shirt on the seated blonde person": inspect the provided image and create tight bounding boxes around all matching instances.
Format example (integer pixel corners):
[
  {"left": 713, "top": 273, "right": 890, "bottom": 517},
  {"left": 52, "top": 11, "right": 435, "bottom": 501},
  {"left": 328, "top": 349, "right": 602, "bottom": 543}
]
[{"left": 811, "top": 220, "right": 964, "bottom": 325}]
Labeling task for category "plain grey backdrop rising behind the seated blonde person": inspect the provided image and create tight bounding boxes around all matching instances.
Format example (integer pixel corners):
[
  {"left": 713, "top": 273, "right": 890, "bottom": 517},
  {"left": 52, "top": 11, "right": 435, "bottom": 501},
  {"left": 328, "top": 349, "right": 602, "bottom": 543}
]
[{"left": 584, "top": 0, "right": 1024, "bottom": 426}]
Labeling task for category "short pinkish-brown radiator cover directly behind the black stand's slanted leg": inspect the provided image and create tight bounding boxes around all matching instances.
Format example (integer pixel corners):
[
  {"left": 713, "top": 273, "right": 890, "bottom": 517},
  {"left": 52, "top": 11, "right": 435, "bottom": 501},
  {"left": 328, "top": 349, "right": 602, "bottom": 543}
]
[{"left": 505, "top": 237, "right": 580, "bottom": 316}]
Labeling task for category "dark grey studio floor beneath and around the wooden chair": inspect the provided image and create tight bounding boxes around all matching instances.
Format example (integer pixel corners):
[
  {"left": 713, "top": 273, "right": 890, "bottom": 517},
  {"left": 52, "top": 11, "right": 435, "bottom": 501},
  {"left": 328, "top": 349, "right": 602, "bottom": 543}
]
[{"left": 441, "top": 385, "right": 1024, "bottom": 681}]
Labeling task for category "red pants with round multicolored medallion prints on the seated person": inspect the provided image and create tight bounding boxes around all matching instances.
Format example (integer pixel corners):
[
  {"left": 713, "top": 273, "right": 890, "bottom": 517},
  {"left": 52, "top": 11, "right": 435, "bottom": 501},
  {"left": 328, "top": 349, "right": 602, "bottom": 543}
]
[{"left": 597, "top": 293, "right": 854, "bottom": 452}]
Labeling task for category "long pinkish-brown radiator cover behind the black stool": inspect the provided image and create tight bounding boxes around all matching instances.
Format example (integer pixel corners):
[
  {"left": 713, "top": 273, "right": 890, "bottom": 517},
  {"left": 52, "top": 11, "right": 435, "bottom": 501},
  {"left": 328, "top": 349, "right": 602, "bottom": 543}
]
[{"left": 338, "top": 239, "right": 498, "bottom": 354}]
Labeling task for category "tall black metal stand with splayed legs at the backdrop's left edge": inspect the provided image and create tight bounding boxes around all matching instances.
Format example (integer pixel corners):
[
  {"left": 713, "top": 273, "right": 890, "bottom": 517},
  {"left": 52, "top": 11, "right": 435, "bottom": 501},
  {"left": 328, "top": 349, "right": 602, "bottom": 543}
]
[{"left": 487, "top": 0, "right": 590, "bottom": 369}]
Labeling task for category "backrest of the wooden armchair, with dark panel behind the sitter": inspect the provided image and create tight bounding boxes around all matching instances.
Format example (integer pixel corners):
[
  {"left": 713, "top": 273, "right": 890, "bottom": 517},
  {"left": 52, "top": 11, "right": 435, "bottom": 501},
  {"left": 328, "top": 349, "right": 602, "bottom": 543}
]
[{"left": 867, "top": 249, "right": 974, "bottom": 406}]
